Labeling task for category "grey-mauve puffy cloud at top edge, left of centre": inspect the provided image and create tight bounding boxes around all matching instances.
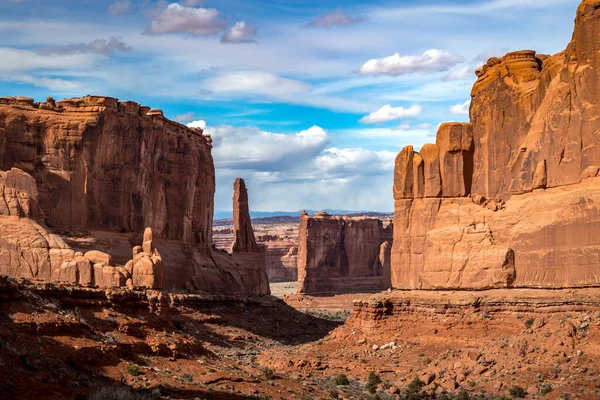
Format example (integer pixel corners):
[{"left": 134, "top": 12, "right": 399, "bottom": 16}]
[{"left": 144, "top": 3, "right": 227, "bottom": 36}]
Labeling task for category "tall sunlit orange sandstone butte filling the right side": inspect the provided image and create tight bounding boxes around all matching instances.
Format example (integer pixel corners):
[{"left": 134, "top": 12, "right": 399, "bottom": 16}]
[{"left": 391, "top": 0, "right": 600, "bottom": 289}]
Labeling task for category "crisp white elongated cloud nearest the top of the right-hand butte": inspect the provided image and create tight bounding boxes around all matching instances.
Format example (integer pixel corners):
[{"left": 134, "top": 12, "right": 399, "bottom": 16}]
[{"left": 358, "top": 49, "right": 464, "bottom": 76}]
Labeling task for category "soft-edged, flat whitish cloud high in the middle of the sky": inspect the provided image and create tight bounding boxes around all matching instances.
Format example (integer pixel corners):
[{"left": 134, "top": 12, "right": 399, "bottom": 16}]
[{"left": 203, "top": 71, "right": 311, "bottom": 96}]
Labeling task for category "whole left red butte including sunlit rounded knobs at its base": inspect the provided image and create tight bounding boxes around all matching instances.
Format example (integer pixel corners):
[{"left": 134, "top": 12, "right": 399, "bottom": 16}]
[{"left": 0, "top": 96, "right": 269, "bottom": 294}]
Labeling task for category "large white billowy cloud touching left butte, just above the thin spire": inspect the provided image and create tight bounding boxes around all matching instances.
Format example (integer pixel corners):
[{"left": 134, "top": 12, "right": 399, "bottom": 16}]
[{"left": 205, "top": 125, "right": 329, "bottom": 171}]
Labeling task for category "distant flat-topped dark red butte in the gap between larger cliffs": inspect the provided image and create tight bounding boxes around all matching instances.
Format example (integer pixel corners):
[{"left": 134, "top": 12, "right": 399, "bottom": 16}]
[{"left": 298, "top": 212, "right": 393, "bottom": 293}]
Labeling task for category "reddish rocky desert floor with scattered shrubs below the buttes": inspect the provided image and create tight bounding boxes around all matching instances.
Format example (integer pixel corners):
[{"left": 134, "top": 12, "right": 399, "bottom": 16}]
[{"left": 0, "top": 278, "right": 600, "bottom": 399}]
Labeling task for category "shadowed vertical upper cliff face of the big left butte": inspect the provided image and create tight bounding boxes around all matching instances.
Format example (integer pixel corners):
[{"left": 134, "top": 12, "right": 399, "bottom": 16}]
[{"left": 0, "top": 97, "right": 215, "bottom": 248}]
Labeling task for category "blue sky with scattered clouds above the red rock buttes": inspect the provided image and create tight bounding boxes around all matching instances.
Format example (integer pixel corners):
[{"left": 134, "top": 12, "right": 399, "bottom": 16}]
[{"left": 0, "top": 0, "right": 579, "bottom": 211}]
